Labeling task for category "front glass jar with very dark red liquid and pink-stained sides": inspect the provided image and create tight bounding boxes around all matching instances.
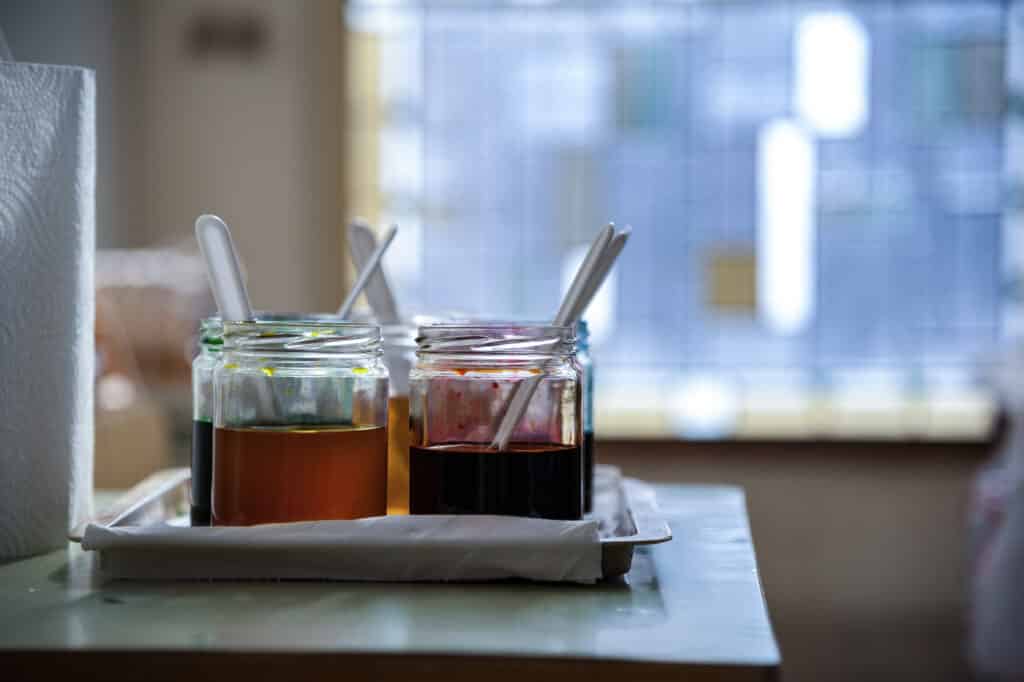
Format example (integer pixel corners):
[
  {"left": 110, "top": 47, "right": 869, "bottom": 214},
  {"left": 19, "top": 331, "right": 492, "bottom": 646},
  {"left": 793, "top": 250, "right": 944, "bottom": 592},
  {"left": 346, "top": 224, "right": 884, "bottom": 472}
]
[{"left": 410, "top": 324, "right": 583, "bottom": 519}]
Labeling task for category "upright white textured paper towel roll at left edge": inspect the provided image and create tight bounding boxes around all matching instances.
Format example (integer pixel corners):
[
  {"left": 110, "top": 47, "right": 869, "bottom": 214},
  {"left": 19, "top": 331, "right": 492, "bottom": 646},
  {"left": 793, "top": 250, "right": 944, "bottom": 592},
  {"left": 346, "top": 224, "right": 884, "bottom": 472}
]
[{"left": 0, "top": 62, "right": 95, "bottom": 558}]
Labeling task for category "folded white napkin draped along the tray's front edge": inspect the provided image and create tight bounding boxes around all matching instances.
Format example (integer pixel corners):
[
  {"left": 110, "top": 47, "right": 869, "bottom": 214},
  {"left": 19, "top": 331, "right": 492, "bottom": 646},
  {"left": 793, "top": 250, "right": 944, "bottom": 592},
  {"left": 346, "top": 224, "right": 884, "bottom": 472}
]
[{"left": 82, "top": 515, "right": 601, "bottom": 583}]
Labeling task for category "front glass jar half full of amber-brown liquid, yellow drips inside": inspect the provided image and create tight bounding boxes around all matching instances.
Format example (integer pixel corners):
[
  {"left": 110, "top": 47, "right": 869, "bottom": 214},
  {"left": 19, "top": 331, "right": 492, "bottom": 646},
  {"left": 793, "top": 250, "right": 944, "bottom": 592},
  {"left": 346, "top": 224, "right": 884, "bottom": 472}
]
[{"left": 212, "top": 319, "right": 388, "bottom": 525}]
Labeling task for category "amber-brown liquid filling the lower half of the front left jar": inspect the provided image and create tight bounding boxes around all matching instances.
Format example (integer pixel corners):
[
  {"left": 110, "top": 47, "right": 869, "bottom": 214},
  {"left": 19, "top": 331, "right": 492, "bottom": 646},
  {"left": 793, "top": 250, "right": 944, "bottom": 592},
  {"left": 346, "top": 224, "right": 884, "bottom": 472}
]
[{"left": 213, "top": 426, "right": 388, "bottom": 525}]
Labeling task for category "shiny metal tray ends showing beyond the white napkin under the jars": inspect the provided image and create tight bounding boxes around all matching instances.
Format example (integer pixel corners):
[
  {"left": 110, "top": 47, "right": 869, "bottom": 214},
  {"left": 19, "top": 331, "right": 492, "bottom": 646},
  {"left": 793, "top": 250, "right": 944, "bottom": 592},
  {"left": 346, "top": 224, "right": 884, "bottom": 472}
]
[{"left": 69, "top": 458, "right": 672, "bottom": 579}]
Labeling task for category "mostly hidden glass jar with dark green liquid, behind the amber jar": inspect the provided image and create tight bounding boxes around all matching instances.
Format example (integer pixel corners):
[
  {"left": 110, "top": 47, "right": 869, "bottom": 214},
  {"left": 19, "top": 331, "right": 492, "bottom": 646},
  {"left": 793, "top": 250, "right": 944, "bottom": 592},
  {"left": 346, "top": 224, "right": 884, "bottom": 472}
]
[{"left": 189, "top": 317, "right": 223, "bottom": 525}]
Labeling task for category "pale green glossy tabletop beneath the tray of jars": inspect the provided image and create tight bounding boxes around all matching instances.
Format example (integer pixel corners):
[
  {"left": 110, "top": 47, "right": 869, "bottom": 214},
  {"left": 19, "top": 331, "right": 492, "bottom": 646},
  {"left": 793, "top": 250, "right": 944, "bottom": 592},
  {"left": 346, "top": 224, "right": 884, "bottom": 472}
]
[{"left": 0, "top": 486, "right": 779, "bottom": 682}]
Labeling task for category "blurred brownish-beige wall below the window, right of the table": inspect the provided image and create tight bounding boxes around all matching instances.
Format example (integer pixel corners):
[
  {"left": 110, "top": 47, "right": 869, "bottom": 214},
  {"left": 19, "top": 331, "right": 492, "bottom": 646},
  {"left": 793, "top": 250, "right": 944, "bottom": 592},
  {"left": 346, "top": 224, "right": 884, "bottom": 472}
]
[{"left": 598, "top": 443, "right": 983, "bottom": 682}]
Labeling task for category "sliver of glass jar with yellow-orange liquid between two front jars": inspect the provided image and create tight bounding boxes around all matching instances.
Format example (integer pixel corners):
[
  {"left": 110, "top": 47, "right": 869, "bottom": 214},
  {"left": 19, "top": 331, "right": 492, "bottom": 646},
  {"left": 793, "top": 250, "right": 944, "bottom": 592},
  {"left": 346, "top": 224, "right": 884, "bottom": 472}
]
[{"left": 381, "top": 325, "right": 417, "bottom": 514}]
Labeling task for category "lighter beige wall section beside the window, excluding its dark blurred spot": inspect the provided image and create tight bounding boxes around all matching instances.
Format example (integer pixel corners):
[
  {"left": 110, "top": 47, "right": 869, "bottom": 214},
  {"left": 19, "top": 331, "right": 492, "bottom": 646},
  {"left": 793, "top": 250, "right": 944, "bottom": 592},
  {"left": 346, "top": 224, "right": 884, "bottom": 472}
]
[{"left": 133, "top": 0, "right": 344, "bottom": 310}]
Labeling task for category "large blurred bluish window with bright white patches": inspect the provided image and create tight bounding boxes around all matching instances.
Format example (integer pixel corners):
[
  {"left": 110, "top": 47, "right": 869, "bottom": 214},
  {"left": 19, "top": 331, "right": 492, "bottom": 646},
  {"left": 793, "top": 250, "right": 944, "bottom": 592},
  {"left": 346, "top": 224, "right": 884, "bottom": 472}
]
[{"left": 345, "top": 0, "right": 1008, "bottom": 438}]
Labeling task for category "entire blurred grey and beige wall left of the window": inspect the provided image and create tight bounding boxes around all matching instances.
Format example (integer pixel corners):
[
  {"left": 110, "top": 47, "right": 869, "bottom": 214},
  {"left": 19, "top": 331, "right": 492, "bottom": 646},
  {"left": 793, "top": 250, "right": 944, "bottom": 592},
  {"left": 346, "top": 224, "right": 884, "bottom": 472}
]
[{"left": 0, "top": 0, "right": 346, "bottom": 310}]
